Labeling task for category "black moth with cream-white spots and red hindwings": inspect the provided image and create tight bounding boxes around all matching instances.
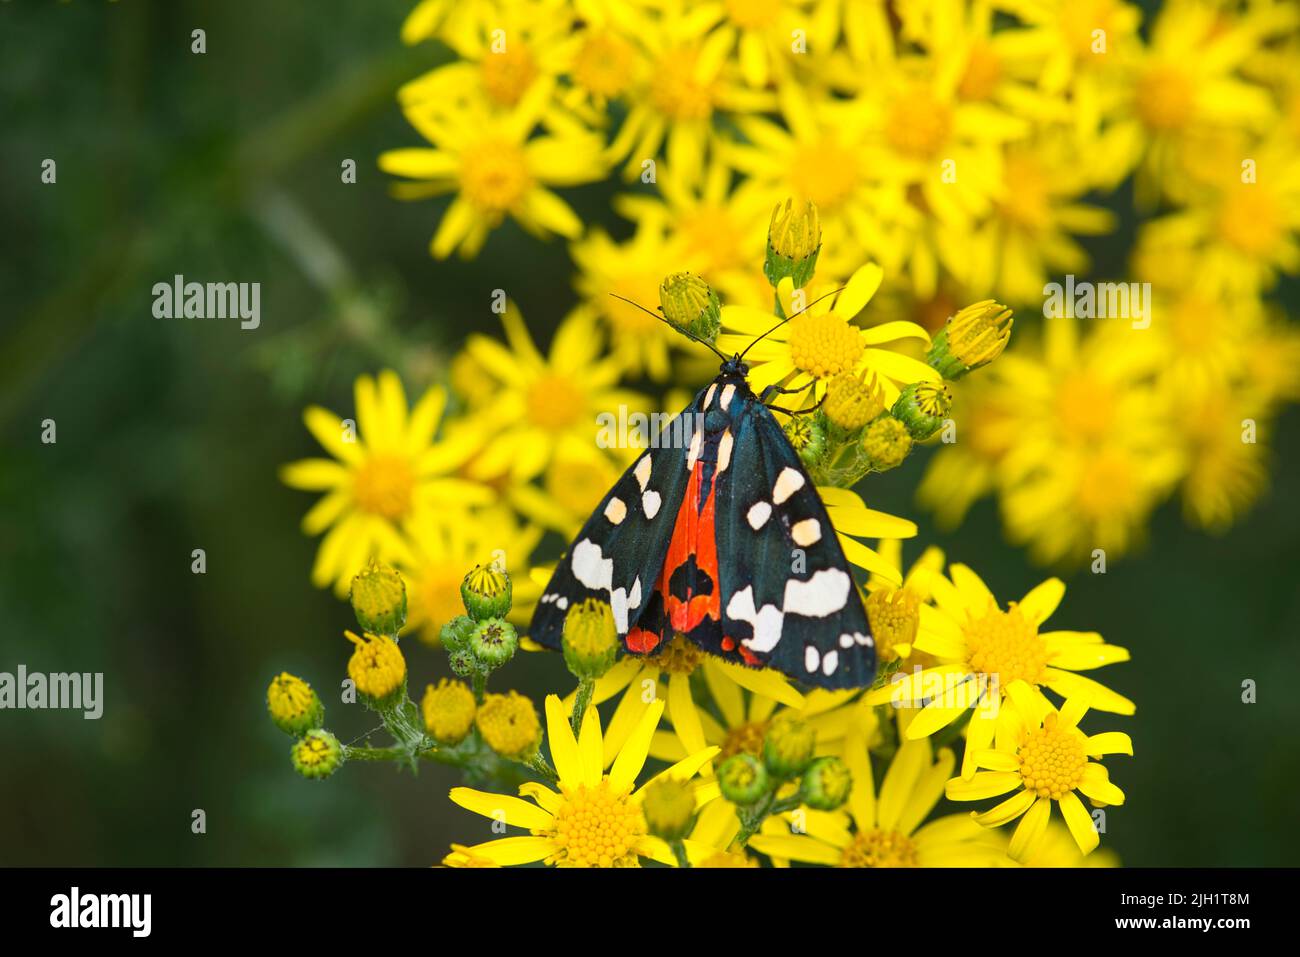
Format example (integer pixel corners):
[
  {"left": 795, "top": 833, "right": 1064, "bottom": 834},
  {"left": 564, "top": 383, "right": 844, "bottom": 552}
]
[{"left": 530, "top": 363, "right": 875, "bottom": 688}]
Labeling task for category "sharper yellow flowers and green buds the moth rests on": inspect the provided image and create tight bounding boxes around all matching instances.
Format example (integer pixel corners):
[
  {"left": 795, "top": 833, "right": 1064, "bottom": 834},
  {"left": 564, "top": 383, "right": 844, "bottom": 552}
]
[{"left": 270, "top": 180, "right": 1134, "bottom": 867}]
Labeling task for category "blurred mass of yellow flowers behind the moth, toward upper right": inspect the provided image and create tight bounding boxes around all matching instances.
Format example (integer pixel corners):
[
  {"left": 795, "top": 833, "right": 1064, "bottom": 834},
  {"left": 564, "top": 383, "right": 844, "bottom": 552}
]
[{"left": 379, "top": 0, "right": 1300, "bottom": 566}]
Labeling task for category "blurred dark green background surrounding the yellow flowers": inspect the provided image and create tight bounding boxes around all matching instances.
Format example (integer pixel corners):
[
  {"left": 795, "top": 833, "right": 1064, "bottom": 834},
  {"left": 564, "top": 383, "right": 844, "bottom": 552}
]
[{"left": 0, "top": 0, "right": 1300, "bottom": 866}]
